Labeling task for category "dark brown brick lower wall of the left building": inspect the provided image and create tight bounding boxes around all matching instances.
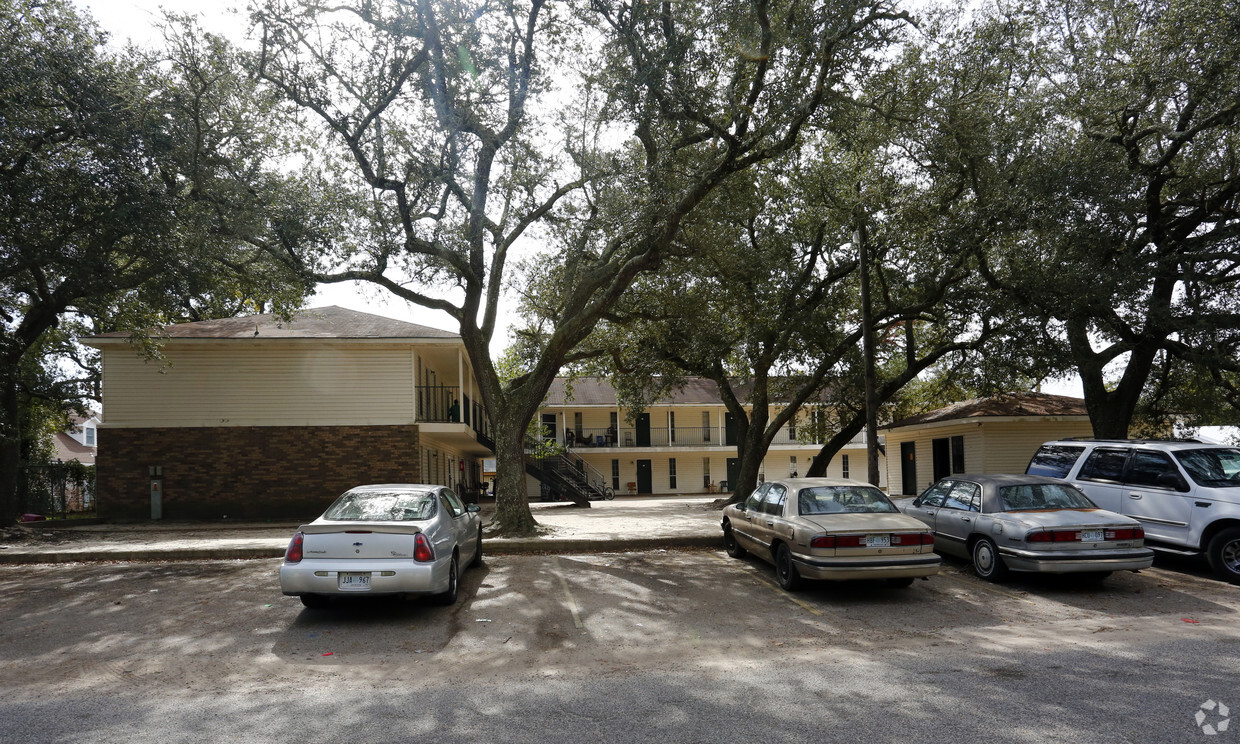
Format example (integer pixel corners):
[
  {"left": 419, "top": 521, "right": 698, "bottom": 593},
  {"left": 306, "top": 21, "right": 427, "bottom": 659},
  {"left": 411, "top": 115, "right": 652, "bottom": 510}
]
[{"left": 95, "top": 425, "right": 420, "bottom": 521}]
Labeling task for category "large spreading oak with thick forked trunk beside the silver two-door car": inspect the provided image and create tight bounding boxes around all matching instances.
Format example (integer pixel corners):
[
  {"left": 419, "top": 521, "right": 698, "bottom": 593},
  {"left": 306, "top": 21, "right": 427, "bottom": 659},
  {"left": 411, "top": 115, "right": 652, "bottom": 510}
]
[{"left": 253, "top": 0, "right": 901, "bottom": 533}]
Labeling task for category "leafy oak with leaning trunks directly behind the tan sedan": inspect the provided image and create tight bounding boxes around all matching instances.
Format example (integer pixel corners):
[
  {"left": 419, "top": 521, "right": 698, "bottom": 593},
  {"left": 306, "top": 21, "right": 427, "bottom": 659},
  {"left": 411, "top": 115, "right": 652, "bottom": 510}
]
[{"left": 562, "top": 13, "right": 1037, "bottom": 501}]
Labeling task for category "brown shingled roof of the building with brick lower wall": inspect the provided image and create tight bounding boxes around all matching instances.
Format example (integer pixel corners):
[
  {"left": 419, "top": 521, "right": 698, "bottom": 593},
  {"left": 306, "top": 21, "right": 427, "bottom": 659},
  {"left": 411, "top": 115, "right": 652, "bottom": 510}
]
[{"left": 84, "top": 306, "right": 460, "bottom": 341}]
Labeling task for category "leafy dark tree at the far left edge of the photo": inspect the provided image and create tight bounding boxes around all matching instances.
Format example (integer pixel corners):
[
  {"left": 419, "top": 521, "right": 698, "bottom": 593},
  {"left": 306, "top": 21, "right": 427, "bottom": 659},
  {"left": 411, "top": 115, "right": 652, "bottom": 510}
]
[{"left": 0, "top": 0, "right": 304, "bottom": 523}]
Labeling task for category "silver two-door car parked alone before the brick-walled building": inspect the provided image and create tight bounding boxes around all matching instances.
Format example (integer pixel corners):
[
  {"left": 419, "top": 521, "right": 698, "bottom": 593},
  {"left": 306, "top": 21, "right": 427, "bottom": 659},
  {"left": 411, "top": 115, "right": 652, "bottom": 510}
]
[{"left": 280, "top": 484, "right": 482, "bottom": 608}]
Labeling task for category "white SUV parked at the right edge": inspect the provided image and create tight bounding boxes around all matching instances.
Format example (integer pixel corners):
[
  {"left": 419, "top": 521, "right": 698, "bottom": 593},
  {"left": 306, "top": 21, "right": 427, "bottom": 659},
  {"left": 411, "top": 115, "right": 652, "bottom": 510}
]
[{"left": 1025, "top": 439, "right": 1240, "bottom": 584}]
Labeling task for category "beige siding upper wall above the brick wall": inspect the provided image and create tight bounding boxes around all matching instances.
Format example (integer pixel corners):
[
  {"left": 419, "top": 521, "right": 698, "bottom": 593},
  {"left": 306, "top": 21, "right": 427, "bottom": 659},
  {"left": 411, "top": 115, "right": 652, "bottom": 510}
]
[{"left": 103, "top": 342, "right": 413, "bottom": 427}]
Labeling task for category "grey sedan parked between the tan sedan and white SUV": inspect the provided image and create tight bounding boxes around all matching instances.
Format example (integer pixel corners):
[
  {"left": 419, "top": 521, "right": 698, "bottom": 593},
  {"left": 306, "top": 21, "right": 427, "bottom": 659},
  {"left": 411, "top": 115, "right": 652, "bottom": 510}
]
[{"left": 901, "top": 475, "right": 1154, "bottom": 582}]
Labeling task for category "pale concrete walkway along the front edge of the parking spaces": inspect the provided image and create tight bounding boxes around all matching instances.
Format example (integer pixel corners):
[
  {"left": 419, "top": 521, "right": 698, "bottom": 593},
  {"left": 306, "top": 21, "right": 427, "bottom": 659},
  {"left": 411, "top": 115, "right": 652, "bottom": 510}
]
[{"left": 0, "top": 496, "right": 723, "bottom": 563}]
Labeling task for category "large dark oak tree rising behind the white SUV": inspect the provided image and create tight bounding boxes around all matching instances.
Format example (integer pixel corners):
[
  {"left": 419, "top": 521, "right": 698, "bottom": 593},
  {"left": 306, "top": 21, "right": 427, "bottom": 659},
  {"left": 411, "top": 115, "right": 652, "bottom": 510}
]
[{"left": 949, "top": 0, "right": 1240, "bottom": 438}]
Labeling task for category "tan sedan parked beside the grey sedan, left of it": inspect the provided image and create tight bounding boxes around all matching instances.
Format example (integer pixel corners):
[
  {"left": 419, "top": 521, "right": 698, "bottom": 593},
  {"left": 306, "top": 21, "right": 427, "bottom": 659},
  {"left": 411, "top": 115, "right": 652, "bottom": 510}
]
[{"left": 722, "top": 477, "right": 941, "bottom": 591}]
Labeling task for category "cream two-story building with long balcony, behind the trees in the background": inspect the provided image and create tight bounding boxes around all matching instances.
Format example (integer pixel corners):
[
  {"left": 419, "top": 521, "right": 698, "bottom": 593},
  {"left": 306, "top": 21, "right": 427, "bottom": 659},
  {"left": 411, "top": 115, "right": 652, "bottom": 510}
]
[{"left": 527, "top": 377, "right": 885, "bottom": 501}]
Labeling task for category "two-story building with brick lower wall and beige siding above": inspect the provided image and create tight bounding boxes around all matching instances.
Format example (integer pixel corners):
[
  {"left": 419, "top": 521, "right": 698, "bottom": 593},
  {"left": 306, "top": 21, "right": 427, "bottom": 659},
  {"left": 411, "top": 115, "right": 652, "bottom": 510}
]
[{"left": 83, "top": 308, "right": 492, "bottom": 520}]
